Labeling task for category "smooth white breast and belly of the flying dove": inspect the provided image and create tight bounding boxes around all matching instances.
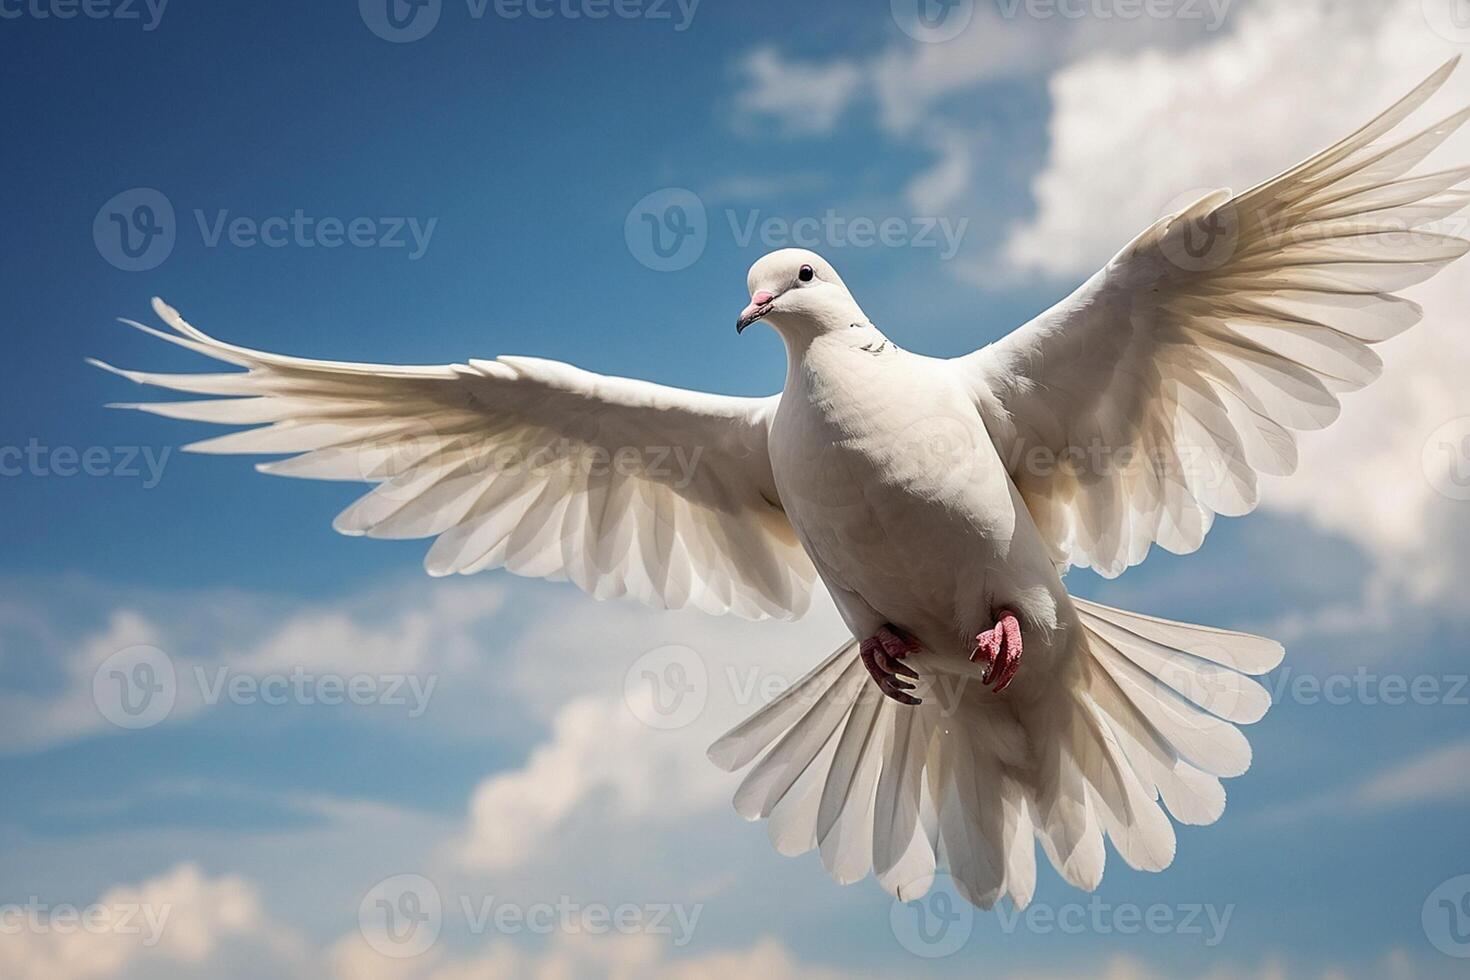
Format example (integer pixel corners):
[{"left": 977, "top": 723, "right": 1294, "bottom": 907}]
[{"left": 772, "top": 335, "right": 1060, "bottom": 644}]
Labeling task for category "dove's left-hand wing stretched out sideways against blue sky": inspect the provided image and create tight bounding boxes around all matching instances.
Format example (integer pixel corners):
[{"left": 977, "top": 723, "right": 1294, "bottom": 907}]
[{"left": 93, "top": 300, "right": 816, "bottom": 619}]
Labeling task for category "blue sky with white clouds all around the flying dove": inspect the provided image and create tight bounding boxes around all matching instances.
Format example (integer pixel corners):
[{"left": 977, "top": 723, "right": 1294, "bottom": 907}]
[{"left": 0, "top": 0, "right": 1470, "bottom": 980}]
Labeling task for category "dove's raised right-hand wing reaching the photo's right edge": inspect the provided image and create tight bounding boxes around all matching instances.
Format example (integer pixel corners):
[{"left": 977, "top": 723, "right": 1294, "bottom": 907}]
[{"left": 951, "top": 62, "right": 1470, "bottom": 576}]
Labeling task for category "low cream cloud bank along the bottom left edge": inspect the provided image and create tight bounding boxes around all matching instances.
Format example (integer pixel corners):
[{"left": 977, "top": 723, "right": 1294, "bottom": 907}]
[{"left": 0, "top": 862, "right": 856, "bottom": 980}]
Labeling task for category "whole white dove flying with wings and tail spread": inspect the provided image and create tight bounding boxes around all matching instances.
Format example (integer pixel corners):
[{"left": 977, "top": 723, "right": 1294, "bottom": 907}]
[{"left": 98, "top": 62, "right": 1470, "bottom": 908}]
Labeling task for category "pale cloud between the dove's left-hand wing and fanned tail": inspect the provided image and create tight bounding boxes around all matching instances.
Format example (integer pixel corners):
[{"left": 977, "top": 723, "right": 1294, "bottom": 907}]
[{"left": 460, "top": 595, "right": 845, "bottom": 871}]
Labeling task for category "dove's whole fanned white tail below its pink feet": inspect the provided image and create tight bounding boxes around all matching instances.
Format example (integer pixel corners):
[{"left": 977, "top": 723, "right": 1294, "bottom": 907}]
[{"left": 710, "top": 599, "right": 1283, "bottom": 908}]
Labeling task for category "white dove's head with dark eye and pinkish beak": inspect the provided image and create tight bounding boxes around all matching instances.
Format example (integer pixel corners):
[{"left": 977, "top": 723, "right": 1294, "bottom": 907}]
[{"left": 735, "top": 248, "right": 867, "bottom": 341}]
